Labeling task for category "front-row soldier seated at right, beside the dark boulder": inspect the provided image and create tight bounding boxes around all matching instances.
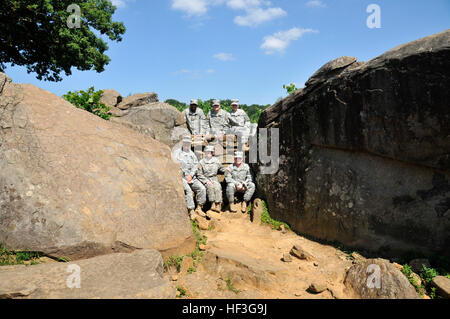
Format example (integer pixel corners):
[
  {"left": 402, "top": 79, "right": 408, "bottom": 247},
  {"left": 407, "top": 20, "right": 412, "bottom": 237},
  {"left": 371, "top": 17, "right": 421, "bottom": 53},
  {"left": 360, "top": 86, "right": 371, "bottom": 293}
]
[{"left": 225, "top": 151, "right": 256, "bottom": 213}]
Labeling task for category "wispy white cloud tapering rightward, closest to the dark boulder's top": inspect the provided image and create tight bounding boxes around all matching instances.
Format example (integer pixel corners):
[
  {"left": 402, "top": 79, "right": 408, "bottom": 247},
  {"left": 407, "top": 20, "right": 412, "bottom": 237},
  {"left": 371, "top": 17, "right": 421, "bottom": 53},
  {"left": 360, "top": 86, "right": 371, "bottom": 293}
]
[{"left": 261, "top": 28, "right": 319, "bottom": 54}]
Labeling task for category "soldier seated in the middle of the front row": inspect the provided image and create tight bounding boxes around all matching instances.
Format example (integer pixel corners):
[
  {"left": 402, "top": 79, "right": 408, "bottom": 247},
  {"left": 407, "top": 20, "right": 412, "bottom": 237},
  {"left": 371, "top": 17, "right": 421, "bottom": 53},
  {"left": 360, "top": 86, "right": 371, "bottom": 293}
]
[{"left": 197, "top": 145, "right": 226, "bottom": 213}]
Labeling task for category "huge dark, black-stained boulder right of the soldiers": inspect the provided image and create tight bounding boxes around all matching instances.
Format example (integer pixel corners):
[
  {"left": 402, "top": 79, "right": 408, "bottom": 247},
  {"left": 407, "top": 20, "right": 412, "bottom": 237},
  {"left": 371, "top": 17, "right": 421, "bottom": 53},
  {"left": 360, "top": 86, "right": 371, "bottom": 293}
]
[{"left": 254, "top": 30, "right": 450, "bottom": 256}]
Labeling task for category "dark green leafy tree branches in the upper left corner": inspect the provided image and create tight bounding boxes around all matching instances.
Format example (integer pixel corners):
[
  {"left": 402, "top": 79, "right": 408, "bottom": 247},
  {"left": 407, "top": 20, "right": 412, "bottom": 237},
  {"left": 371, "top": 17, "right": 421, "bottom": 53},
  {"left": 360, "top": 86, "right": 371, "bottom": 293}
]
[{"left": 0, "top": 0, "right": 125, "bottom": 81}]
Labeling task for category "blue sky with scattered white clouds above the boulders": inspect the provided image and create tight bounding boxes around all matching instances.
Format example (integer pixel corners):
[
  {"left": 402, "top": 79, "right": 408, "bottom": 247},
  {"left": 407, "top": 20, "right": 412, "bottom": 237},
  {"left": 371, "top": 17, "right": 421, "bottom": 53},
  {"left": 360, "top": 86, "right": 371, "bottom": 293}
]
[{"left": 6, "top": 0, "right": 450, "bottom": 104}]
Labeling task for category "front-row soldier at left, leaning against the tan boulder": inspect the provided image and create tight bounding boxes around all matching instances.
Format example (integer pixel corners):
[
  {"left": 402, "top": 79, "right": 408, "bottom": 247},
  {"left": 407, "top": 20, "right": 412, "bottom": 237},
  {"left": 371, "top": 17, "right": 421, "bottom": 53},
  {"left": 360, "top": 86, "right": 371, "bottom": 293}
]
[{"left": 173, "top": 135, "right": 206, "bottom": 220}]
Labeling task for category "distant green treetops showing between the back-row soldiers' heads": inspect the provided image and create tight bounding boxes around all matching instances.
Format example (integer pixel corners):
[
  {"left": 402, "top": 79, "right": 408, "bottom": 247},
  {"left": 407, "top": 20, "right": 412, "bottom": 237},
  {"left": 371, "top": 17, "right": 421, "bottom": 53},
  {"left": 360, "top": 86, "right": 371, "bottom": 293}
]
[{"left": 165, "top": 99, "right": 270, "bottom": 123}]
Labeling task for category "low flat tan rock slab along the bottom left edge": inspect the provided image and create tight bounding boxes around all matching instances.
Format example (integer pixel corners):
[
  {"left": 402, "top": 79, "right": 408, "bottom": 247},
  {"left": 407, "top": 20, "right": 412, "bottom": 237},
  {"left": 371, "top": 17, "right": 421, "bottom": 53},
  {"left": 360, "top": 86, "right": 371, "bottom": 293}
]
[{"left": 0, "top": 249, "right": 176, "bottom": 299}]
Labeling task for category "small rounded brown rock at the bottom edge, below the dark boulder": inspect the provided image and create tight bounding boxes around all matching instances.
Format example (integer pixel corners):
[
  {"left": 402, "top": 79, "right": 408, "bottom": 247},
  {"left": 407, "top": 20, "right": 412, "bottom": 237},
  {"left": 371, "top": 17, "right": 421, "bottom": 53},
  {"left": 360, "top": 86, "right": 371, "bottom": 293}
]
[{"left": 344, "top": 258, "right": 419, "bottom": 299}]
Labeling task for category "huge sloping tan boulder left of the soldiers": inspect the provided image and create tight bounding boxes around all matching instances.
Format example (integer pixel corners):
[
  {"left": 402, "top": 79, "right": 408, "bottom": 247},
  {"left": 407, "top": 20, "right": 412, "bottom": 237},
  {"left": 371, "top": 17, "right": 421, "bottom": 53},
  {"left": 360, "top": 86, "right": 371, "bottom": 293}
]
[{"left": 0, "top": 74, "right": 195, "bottom": 260}]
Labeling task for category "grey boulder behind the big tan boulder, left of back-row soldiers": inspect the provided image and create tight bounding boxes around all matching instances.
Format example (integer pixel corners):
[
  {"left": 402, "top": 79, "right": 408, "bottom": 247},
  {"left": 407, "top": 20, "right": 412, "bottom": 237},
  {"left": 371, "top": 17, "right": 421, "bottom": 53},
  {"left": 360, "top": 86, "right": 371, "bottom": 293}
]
[{"left": 111, "top": 102, "right": 189, "bottom": 147}]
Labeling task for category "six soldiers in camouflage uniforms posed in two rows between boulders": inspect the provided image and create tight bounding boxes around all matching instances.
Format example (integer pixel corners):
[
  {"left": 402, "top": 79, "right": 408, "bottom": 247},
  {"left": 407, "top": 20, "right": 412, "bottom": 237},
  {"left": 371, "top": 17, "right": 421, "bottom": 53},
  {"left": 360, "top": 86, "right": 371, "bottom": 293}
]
[{"left": 174, "top": 100, "right": 256, "bottom": 219}]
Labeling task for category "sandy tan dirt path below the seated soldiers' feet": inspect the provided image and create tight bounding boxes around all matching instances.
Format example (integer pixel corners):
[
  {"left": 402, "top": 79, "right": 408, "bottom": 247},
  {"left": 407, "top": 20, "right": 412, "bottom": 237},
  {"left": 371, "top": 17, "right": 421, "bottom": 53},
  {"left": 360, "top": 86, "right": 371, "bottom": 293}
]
[{"left": 167, "top": 212, "right": 358, "bottom": 299}]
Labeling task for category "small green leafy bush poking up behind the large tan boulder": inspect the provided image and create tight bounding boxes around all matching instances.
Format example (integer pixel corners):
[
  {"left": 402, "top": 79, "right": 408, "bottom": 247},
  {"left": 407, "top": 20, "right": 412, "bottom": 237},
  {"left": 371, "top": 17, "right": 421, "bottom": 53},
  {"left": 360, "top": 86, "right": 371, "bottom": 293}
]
[{"left": 63, "top": 86, "right": 111, "bottom": 120}]
